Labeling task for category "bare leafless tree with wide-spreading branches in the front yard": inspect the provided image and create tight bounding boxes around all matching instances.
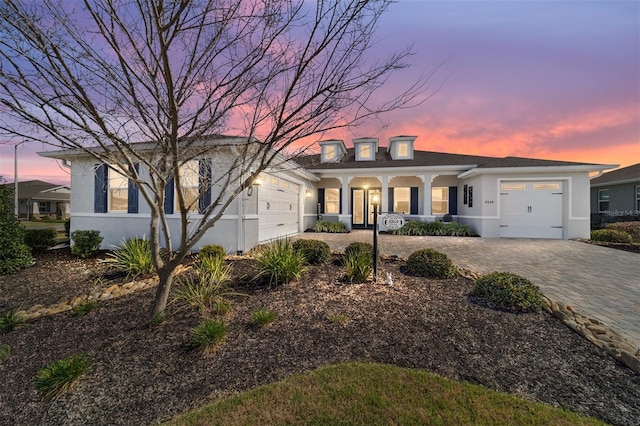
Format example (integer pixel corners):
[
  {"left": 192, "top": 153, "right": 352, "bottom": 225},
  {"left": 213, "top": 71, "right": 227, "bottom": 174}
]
[{"left": 0, "top": 0, "right": 428, "bottom": 314}]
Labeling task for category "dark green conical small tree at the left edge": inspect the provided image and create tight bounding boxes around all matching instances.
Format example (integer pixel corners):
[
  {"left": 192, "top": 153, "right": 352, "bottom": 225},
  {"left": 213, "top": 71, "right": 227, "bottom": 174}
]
[{"left": 0, "top": 176, "right": 33, "bottom": 275}]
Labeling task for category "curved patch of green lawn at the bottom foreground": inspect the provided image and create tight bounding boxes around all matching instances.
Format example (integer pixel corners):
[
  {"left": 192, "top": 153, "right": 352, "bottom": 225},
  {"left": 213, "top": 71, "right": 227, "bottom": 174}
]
[{"left": 167, "top": 363, "right": 604, "bottom": 425}]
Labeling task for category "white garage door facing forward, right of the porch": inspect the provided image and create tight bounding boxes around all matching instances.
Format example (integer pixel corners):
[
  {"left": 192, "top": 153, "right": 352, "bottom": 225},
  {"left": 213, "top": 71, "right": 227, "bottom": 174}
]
[{"left": 500, "top": 181, "right": 563, "bottom": 238}]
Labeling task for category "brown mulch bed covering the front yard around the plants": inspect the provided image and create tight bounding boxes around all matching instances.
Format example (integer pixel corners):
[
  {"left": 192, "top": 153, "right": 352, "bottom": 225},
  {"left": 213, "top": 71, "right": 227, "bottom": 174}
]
[{"left": 0, "top": 251, "right": 640, "bottom": 425}]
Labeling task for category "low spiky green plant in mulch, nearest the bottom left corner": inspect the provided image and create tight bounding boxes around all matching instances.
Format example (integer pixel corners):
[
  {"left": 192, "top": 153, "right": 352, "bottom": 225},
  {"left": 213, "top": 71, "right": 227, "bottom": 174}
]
[{"left": 35, "top": 354, "right": 90, "bottom": 398}]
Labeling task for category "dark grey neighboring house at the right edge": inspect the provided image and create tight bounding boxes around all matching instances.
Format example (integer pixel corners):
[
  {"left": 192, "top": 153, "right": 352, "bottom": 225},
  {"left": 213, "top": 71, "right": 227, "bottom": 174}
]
[{"left": 591, "top": 163, "right": 640, "bottom": 215}]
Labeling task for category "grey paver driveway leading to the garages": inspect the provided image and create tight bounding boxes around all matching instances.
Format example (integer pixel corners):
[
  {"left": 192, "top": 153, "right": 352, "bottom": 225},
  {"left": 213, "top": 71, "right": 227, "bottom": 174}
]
[{"left": 295, "top": 231, "right": 640, "bottom": 347}]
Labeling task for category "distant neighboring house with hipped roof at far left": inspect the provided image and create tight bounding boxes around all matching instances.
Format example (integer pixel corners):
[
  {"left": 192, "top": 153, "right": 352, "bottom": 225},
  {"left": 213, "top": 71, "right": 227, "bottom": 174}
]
[{"left": 0, "top": 180, "right": 71, "bottom": 219}]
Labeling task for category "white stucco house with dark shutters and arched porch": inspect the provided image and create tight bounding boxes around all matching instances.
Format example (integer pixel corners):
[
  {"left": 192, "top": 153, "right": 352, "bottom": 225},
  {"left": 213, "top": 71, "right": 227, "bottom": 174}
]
[{"left": 40, "top": 136, "right": 615, "bottom": 252}]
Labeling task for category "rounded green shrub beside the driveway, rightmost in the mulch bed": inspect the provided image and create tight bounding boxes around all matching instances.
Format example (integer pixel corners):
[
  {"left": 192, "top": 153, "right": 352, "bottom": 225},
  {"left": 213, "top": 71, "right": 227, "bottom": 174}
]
[{"left": 473, "top": 272, "right": 542, "bottom": 312}]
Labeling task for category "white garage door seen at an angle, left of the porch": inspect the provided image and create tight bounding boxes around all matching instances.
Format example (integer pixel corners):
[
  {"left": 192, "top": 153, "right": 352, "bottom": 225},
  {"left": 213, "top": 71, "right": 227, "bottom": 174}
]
[{"left": 258, "top": 175, "right": 299, "bottom": 242}]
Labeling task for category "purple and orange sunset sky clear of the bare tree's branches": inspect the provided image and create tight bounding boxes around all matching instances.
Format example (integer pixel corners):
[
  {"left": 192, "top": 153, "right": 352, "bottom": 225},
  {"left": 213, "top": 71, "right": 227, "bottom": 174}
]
[{"left": 0, "top": 0, "right": 640, "bottom": 184}]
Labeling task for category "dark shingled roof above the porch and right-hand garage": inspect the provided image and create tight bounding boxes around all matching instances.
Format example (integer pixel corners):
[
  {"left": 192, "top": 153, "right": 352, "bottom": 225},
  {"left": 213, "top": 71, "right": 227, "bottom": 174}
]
[{"left": 296, "top": 148, "right": 611, "bottom": 171}]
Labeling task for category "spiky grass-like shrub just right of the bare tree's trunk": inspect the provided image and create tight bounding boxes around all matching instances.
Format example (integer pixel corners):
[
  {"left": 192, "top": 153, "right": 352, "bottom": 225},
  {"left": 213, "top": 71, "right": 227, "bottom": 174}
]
[{"left": 173, "top": 251, "right": 239, "bottom": 317}]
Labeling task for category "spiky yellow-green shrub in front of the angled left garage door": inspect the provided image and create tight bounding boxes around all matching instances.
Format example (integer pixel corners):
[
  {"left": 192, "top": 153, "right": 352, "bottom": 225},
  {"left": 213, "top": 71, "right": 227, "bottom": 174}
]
[{"left": 254, "top": 238, "right": 305, "bottom": 285}]
